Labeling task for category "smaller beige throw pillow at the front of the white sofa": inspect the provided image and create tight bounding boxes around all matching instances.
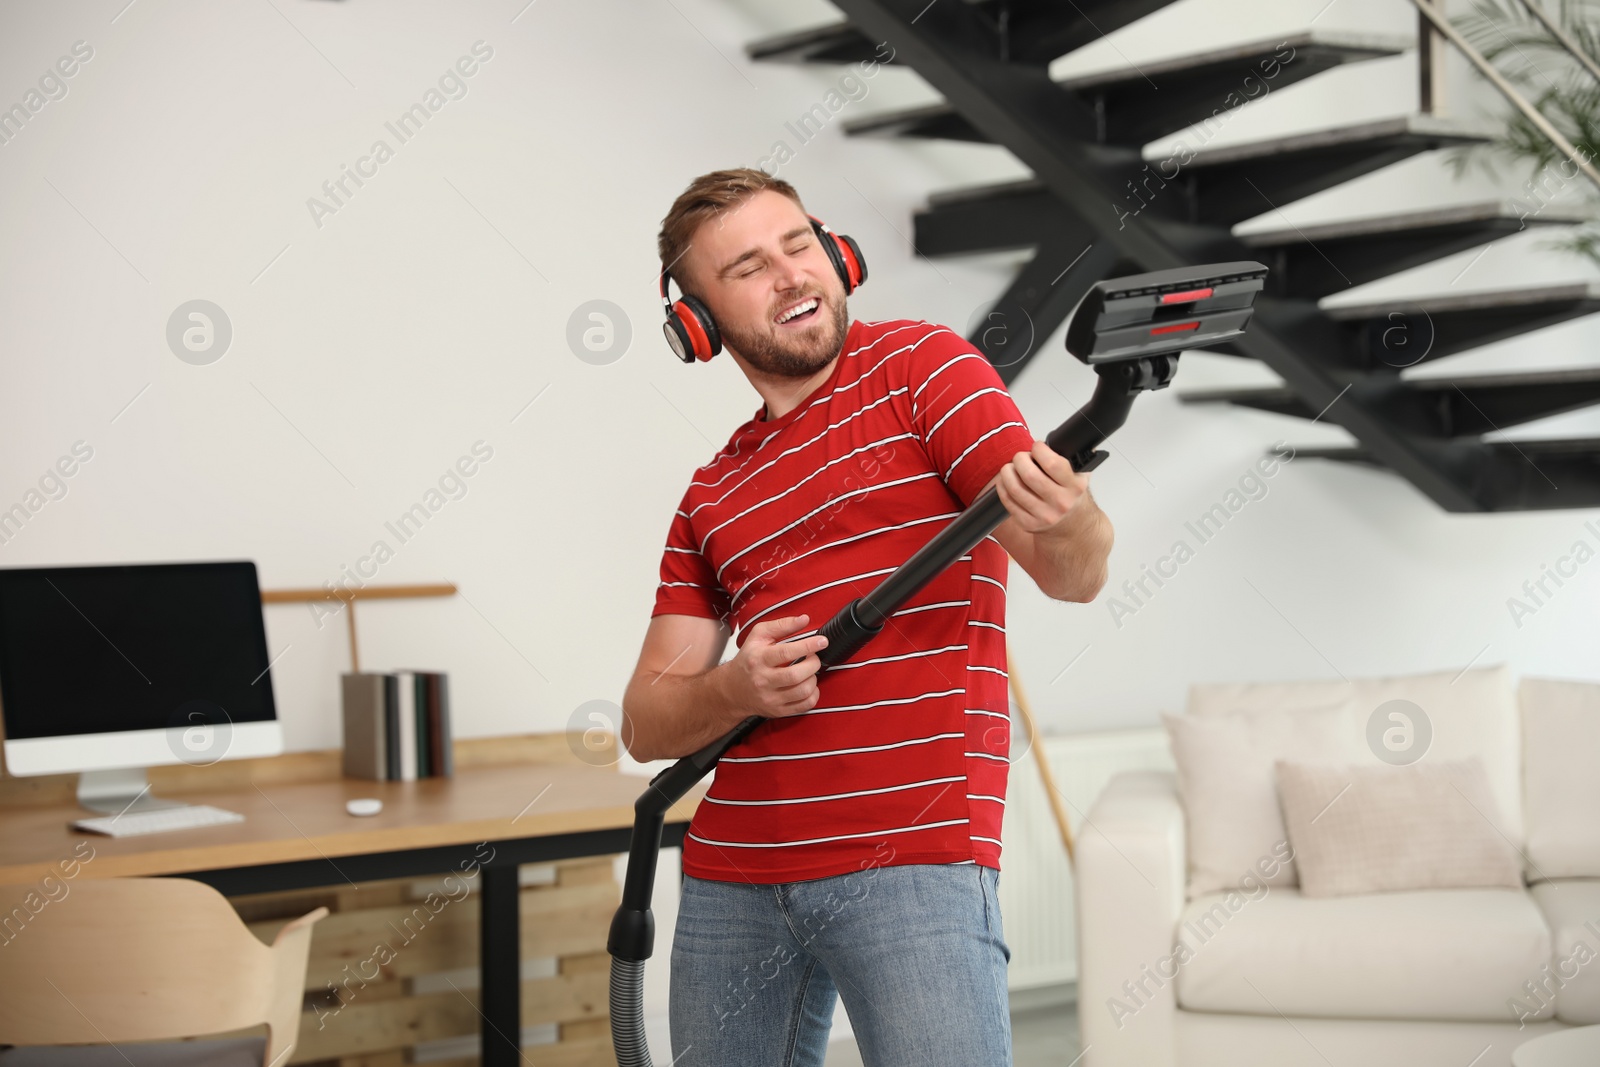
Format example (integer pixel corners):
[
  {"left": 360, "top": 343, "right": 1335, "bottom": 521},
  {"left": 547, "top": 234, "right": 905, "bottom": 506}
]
[{"left": 1277, "top": 758, "right": 1522, "bottom": 897}]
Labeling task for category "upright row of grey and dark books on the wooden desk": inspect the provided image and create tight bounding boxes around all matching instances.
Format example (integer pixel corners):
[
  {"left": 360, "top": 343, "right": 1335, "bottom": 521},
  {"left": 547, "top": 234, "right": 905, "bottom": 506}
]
[{"left": 341, "top": 670, "right": 454, "bottom": 782}]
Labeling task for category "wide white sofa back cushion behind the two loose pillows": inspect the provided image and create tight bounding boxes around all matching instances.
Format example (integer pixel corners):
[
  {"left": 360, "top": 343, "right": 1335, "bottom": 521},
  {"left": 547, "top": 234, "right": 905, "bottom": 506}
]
[{"left": 1187, "top": 665, "right": 1523, "bottom": 849}]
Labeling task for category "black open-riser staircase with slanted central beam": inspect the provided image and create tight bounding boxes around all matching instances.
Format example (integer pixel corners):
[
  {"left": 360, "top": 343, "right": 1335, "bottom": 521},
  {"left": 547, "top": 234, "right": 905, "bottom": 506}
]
[{"left": 747, "top": 0, "right": 1600, "bottom": 512}]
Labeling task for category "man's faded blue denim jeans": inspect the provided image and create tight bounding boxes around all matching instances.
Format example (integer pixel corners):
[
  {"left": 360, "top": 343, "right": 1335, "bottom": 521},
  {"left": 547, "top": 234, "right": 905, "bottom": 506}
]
[{"left": 670, "top": 864, "right": 1011, "bottom": 1067}]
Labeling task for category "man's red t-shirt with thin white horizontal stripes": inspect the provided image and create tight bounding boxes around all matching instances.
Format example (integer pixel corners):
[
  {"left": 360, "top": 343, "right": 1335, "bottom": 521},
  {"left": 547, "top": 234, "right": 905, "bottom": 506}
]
[{"left": 651, "top": 320, "right": 1034, "bottom": 883}]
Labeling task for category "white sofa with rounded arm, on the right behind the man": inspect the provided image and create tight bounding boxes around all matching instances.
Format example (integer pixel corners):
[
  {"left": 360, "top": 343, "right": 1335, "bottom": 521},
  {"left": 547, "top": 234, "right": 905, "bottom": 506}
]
[{"left": 1075, "top": 667, "right": 1600, "bottom": 1067}]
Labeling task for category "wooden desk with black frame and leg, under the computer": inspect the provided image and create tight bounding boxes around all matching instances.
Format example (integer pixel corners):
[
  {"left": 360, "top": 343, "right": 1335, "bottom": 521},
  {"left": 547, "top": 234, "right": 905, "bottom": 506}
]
[{"left": 0, "top": 763, "right": 699, "bottom": 1067}]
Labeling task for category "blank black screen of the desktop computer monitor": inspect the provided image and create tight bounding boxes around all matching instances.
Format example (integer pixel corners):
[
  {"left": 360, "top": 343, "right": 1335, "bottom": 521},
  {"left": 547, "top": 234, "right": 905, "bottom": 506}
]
[{"left": 0, "top": 561, "right": 275, "bottom": 741}]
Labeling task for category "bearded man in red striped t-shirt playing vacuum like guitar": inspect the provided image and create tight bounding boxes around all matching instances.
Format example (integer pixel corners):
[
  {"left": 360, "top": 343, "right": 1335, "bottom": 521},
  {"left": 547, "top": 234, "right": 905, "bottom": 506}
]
[{"left": 622, "top": 168, "right": 1112, "bottom": 1067}]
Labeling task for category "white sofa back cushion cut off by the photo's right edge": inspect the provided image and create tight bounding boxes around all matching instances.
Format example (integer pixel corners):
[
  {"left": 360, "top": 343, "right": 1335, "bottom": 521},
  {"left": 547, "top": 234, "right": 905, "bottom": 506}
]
[{"left": 1517, "top": 678, "right": 1600, "bottom": 880}]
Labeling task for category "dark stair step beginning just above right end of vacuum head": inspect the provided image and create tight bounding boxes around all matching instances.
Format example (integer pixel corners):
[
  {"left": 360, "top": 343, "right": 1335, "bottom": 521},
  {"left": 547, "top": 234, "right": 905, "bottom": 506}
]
[{"left": 1235, "top": 200, "right": 1586, "bottom": 299}]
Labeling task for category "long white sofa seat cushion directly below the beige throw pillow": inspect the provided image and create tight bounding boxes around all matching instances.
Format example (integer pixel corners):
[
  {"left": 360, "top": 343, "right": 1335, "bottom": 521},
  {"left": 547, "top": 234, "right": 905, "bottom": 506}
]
[{"left": 1177, "top": 886, "right": 1550, "bottom": 1021}]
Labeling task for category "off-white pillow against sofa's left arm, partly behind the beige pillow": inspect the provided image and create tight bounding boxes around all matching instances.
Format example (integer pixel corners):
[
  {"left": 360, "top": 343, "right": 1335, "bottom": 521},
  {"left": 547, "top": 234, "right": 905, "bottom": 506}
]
[{"left": 1163, "top": 710, "right": 1355, "bottom": 899}]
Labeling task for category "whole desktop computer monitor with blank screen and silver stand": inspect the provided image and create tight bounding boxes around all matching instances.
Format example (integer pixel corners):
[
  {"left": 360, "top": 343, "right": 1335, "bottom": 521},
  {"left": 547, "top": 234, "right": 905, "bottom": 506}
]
[{"left": 0, "top": 560, "right": 283, "bottom": 813}]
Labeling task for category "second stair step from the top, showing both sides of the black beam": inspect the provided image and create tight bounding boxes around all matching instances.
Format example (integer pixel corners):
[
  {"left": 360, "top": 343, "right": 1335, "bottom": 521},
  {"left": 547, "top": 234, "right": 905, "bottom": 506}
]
[{"left": 845, "top": 30, "right": 1411, "bottom": 147}]
